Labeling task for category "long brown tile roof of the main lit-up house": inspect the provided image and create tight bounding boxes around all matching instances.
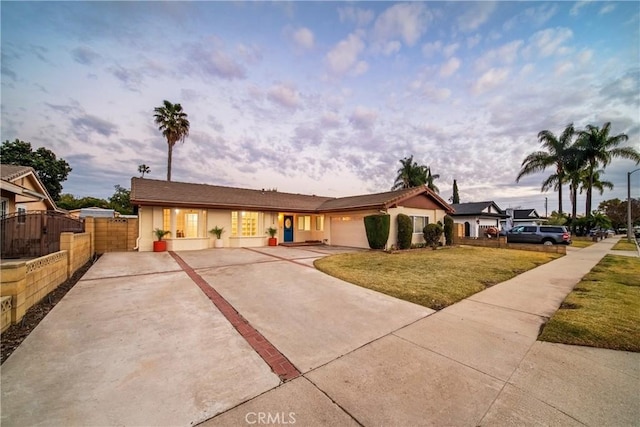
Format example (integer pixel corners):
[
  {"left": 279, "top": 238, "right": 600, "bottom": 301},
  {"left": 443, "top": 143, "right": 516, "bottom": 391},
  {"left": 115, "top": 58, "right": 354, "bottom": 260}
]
[{"left": 131, "top": 178, "right": 449, "bottom": 212}]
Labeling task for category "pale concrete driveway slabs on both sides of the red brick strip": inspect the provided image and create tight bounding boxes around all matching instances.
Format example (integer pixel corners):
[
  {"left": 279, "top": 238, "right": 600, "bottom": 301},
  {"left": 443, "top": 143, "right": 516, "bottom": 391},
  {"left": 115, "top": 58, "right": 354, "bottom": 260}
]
[{"left": 1, "top": 247, "right": 433, "bottom": 426}]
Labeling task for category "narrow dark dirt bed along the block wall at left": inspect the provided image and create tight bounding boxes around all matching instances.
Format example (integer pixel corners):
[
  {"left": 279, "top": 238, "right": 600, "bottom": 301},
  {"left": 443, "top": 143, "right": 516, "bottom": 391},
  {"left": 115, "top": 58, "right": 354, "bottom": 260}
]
[{"left": 0, "top": 255, "right": 99, "bottom": 364}]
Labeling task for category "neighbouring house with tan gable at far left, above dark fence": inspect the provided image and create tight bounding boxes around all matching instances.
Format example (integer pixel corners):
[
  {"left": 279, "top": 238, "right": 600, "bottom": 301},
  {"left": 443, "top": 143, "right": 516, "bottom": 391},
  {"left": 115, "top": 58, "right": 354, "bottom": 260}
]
[{"left": 0, "top": 164, "right": 58, "bottom": 217}]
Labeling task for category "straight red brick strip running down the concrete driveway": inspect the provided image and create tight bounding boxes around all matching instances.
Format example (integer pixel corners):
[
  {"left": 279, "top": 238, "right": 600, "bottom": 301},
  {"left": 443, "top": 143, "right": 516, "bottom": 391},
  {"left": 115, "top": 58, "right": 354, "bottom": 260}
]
[{"left": 169, "top": 251, "right": 300, "bottom": 381}]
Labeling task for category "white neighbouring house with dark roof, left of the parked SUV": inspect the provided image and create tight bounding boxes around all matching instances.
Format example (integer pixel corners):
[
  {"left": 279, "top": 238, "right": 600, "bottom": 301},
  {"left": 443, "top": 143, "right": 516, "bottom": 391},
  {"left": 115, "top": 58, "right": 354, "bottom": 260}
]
[{"left": 449, "top": 201, "right": 508, "bottom": 238}]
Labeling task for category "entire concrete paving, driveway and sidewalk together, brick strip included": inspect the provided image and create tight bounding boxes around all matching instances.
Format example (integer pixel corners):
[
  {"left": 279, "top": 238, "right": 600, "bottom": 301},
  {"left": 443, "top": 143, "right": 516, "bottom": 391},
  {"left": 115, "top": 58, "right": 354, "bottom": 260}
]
[{"left": 1, "top": 239, "right": 640, "bottom": 427}]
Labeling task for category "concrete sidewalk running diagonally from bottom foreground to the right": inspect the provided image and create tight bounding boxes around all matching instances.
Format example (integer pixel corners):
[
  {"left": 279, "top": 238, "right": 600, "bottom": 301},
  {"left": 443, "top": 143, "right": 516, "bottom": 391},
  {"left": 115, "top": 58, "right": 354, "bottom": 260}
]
[{"left": 203, "top": 239, "right": 640, "bottom": 427}]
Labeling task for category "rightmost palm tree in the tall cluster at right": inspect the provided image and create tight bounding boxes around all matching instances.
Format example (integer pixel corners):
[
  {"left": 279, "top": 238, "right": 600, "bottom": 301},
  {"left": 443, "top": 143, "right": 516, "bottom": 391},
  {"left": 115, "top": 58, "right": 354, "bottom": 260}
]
[{"left": 576, "top": 122, "right": 640, "bottom": 215}]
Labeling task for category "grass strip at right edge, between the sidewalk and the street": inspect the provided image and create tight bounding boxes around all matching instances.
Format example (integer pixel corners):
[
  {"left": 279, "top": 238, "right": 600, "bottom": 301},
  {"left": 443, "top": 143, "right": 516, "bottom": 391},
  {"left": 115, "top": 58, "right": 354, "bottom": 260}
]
[{"left": 539, "top": 255, "right": 640, "bottom": 352}]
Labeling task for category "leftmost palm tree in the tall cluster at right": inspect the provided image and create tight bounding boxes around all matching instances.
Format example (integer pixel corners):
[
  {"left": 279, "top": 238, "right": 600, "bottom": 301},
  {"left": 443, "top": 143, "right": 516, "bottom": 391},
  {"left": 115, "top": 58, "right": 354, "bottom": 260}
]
[{"left": 516, "top": 123, "right": 575, "bottom": 214}]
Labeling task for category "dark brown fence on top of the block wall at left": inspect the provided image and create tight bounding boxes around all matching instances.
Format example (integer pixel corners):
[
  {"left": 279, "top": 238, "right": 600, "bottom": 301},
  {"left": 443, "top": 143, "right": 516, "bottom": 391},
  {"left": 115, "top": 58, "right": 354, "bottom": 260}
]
[{"left": 0, "top": 211, "right": 84, "bottom": 258}]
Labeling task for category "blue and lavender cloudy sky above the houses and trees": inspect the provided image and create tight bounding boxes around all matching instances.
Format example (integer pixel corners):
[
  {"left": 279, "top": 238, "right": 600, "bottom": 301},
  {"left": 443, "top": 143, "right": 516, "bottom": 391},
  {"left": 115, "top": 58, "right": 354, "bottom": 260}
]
[{"left": 1, "top": 2, "right": 640, "bottom": 215}]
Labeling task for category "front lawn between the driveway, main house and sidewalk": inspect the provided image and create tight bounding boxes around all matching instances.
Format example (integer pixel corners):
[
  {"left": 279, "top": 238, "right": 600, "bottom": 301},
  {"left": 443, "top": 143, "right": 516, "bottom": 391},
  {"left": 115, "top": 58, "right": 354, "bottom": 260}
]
[{"left": 314, "top": 247, "right": 561, "bottom": 310}]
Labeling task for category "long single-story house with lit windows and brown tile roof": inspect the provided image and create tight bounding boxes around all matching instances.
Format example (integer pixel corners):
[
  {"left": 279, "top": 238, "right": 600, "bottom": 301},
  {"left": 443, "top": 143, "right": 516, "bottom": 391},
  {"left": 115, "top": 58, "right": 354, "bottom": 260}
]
[{"left": 131, "top": 178, "right": 453, "bottom": 251}]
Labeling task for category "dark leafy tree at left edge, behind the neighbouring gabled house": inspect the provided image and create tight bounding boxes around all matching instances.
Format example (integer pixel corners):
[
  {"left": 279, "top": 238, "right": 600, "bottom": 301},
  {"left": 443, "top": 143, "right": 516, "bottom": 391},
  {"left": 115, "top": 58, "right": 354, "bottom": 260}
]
[{"left": 0, "top": 139, "right": 71, "bottom": 201}]
